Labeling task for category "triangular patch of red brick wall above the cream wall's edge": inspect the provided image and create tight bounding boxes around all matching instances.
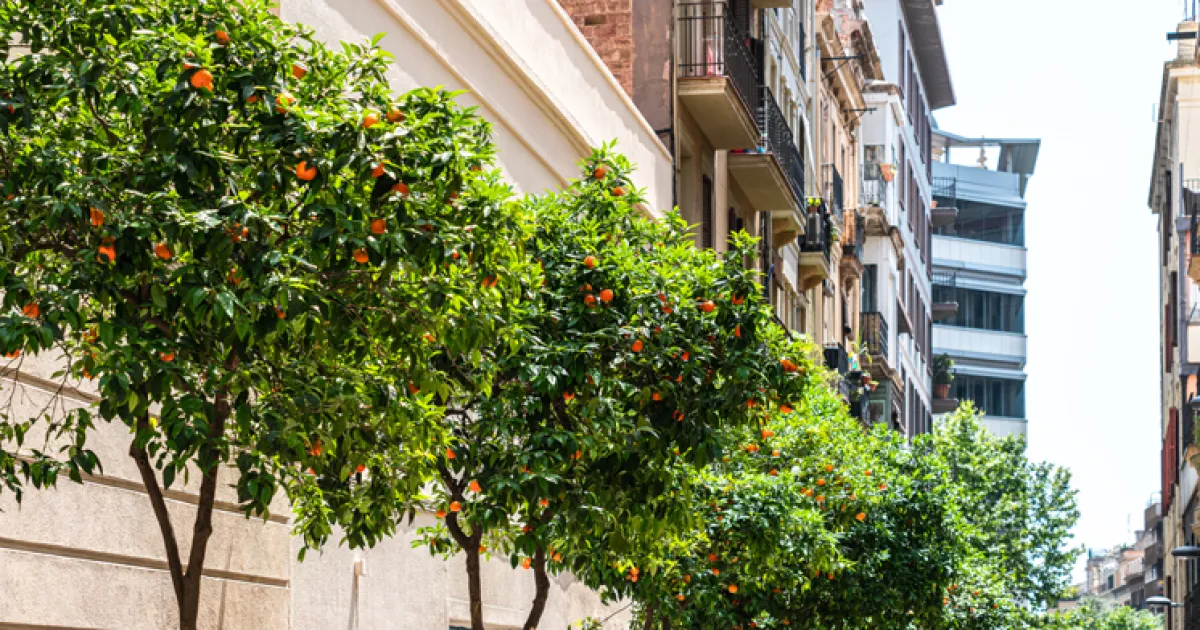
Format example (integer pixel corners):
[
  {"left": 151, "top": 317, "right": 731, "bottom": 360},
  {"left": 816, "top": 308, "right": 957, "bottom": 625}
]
[{"left": 558, "top": 0, "right": 634, "bottom": 96}]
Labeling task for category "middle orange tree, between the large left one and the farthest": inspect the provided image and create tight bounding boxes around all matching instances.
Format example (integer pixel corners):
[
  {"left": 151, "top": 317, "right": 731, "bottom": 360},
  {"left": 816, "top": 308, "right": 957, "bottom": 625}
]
[{"left": 412, "top": 150, "right": 825, "bottom": 629}]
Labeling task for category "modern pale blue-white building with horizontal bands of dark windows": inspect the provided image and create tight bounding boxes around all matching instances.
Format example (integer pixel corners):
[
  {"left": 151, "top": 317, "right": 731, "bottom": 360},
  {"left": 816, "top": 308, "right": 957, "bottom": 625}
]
[{"left": 932, "top": 130, "right": 1040, "bottom": 436}]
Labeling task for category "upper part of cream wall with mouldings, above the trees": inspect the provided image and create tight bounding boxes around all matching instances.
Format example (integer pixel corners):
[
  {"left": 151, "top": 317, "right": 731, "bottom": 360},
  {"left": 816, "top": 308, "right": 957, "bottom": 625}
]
[{"left": 281, "top": 0, "right": 671, "bottom": 211}]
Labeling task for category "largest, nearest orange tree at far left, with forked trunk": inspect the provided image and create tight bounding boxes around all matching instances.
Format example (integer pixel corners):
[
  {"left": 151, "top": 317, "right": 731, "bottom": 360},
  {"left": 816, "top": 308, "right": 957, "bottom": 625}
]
[{"left": 0, "top": 0, "right": 532, "bottom": 628}]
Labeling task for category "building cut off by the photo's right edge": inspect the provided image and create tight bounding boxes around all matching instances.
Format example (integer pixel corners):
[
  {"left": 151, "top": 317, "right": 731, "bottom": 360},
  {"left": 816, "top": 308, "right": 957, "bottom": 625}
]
[{"left": 1147, "top": 15, "right": 1200, "bottom": 630}]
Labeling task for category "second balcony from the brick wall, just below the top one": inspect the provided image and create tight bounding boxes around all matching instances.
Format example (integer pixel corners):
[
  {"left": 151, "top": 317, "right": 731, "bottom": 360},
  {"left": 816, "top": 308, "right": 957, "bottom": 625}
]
[{"left": 728, "top": 85, "right": 804, "bottom": 214}]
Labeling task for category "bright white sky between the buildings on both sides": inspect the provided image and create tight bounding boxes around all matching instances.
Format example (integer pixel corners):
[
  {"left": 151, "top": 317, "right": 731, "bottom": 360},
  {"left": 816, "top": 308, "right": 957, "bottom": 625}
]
[{"left": 935, "top": 0, "right": 1190, "bottom": 578}]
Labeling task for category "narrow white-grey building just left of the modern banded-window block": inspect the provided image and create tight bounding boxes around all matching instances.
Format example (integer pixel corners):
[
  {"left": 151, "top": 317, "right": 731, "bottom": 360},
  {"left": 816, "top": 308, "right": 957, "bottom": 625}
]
[{"left": 854, "top": 0, "right": 955, "bottom": 436}]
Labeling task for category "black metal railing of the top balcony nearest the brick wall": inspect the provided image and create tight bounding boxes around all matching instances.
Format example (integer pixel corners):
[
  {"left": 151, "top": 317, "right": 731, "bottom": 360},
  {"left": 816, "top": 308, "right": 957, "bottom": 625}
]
[{"left": 679, "top": 2, "right": 762, "bottom": 115}]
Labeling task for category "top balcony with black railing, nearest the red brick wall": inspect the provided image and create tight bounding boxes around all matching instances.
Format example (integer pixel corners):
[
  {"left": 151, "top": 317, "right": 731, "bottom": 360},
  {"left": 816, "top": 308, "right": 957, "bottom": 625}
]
[{"left": 678, "top": 2, "right": 762, "bottom": 150}]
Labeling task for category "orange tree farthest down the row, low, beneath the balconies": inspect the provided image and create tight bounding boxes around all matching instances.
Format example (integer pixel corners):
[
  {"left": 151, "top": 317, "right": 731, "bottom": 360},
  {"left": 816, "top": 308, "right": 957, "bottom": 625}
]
[{"left": 577, "top": 368, "right": 958, "bottom": 629}]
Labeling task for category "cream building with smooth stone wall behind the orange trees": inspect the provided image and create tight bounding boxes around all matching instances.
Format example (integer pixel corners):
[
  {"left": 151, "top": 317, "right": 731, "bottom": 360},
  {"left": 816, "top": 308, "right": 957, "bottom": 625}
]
[{"left": 0, "top": 0, "right": 667, "bottom": 630}]
